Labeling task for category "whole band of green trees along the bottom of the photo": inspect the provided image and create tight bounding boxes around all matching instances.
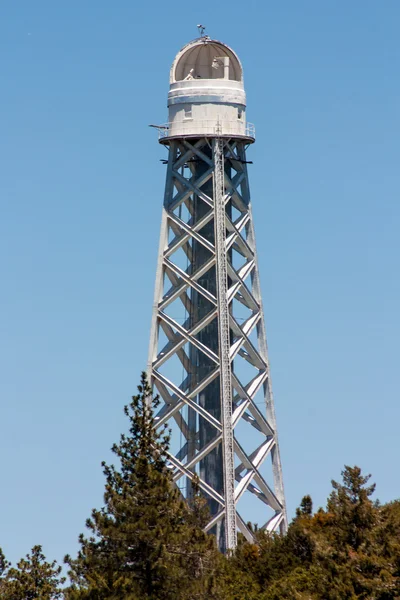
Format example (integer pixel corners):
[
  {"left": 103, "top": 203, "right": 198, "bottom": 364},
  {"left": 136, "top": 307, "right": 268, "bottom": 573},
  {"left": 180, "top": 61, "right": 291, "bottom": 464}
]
[{"left": 5, "top": 374, "right": 400, "bottom": 600}]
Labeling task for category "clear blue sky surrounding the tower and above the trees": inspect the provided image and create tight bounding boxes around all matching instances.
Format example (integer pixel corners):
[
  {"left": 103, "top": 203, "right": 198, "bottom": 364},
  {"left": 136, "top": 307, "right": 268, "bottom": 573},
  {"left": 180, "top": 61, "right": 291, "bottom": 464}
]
[{"left": 0, "top": 0, "right": 400, "bottom": 561}]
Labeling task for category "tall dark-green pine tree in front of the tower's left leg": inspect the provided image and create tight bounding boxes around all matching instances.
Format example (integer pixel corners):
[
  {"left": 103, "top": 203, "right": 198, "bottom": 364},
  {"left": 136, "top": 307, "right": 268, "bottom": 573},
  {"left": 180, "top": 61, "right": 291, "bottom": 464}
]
[{"left": 65, "top": 373, "right": 222, "bottom": 600}]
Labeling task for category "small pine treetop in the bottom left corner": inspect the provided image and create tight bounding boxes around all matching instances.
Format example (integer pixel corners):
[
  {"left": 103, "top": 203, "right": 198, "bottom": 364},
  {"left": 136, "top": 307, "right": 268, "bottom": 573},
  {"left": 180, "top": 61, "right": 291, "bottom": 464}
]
[{"left": 0, "top": 546, "right": 65, "bottom": 600}]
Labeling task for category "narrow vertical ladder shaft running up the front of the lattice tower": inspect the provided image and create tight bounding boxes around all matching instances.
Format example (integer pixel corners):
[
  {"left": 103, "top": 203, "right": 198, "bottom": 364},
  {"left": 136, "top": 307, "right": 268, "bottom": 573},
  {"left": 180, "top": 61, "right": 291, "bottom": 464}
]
[{"left": 213, "top": 135, "right": 236, "bottom": 551}]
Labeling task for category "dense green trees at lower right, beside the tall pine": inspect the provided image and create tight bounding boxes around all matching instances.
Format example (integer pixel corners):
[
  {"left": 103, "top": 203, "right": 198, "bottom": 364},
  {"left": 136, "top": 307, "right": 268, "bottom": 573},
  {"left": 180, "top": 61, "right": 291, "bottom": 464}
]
[{"left": 222, "top": 466, "right": 400, "bottom": 600}]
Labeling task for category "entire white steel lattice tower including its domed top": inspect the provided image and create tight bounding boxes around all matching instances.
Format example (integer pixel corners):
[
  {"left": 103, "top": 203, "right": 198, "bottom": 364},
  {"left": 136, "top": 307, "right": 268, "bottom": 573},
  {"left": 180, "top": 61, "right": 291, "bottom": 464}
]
[{"left": 148, "top": 36, "right": 287, "bottom": 551}]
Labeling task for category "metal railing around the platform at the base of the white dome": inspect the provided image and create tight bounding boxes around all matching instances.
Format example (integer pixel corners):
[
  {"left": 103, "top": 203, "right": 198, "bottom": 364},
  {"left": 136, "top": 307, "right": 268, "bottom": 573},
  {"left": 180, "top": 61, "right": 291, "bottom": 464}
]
[{"left": 158, "top": 119, "right": 256, "bottom": 140}]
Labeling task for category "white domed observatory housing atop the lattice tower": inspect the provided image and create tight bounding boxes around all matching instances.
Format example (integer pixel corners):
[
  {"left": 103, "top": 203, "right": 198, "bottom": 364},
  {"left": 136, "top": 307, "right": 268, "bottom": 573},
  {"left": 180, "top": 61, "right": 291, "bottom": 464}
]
[{"left": 163, "top": 37, "right": 254, "bottom": 141}]
